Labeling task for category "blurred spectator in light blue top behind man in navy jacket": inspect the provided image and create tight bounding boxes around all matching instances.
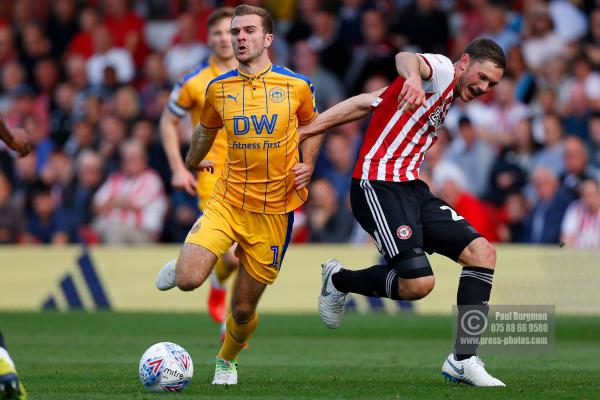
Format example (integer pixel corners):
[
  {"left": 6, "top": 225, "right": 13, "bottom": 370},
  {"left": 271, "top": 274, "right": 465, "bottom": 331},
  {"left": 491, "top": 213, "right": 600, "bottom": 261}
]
[{"left": 533, "top": 114, "right": 565, "bottom": 176}]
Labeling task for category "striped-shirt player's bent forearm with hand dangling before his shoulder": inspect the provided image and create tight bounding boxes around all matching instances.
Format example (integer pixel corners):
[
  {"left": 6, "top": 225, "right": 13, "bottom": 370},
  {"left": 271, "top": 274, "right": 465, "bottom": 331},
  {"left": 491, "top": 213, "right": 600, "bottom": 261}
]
[{"left": 396, "top": 52, "right": 432, "bottom": 110}]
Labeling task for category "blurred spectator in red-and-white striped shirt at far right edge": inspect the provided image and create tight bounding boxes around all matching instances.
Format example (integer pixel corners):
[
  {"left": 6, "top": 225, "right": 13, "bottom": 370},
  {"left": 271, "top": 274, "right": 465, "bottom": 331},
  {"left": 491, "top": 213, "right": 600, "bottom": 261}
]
[{"left": 561, "top": 179, "right": 600, "bottom": 249}]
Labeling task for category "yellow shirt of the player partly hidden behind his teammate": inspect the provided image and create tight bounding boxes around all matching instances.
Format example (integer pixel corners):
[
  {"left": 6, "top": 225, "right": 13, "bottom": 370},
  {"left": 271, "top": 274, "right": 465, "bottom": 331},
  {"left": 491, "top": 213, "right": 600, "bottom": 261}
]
[{"left": 167, "top": 56, "right": 227, "bottom": 209}]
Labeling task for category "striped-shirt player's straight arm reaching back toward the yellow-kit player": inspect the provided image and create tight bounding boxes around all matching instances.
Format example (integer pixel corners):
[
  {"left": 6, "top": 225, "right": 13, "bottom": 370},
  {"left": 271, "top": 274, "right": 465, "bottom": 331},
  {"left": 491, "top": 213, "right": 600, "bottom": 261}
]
[{"left": 299, "top": 87, "right": 386, "bottom": 141}]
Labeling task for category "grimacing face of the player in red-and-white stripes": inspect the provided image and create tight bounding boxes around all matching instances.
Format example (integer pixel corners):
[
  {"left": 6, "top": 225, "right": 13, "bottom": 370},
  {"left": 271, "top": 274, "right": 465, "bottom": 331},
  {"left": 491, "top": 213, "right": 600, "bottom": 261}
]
[{"left": 457, "top": 54, "right": 504, "bottom": 102}]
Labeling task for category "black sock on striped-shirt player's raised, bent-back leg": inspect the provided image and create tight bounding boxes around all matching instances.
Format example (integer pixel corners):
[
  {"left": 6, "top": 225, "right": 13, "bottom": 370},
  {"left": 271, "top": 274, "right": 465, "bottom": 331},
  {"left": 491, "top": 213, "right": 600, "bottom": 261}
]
[{"left": 331, "top": 265, "right": 401, "bottom": 300}]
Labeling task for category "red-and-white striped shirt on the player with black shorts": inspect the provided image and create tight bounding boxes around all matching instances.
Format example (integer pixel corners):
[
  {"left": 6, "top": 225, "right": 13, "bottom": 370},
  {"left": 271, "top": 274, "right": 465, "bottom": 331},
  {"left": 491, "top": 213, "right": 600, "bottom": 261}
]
[{"left": 352, "top": 54, "right": 454, "bottom": 182}]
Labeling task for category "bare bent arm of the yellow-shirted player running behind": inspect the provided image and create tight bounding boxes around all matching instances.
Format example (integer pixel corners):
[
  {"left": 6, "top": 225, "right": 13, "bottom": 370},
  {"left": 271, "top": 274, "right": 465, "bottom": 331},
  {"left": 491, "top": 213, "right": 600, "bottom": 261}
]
[{"left": 160, "top": 107, "right": 196, "bottom": 196}]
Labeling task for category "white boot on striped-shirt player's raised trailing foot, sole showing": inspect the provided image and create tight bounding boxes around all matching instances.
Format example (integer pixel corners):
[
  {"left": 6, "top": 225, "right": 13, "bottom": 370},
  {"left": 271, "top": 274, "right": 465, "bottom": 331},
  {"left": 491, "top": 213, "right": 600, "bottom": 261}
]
[{"left": 319, "top": 259, "right": 347, "bottom": 329}]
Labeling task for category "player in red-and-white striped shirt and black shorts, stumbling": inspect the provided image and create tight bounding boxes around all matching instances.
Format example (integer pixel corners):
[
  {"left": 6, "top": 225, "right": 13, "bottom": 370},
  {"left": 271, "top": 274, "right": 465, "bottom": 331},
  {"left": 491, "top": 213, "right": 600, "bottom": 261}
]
[{"left": 301, "top": 39, "right": 506, "bottom": 386}]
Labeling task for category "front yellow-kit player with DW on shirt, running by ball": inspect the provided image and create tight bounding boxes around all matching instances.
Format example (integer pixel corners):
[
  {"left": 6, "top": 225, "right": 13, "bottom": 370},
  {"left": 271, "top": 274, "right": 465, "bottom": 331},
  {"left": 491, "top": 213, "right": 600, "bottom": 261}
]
[{"left": 157, "top": 5, "right": 321, "bottom": 385}]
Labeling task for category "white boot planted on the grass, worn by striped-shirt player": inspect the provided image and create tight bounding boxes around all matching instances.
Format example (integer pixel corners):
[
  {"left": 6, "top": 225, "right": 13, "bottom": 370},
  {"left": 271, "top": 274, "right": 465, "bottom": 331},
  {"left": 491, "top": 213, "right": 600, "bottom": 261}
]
[{"left": 442, "top": 353, "right": 506, "bottom": 386}]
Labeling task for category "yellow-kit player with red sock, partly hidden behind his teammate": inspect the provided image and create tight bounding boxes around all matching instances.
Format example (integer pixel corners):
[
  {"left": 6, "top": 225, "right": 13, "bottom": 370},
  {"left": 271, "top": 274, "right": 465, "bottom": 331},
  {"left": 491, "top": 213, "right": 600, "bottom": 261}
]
[{"left": 160, "top": 7, "right": 237, "bottom": 338}]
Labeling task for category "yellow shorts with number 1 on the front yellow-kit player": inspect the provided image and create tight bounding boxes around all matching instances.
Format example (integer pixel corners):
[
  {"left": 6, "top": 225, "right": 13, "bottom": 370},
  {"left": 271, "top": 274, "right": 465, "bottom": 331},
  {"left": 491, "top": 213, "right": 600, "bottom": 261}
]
[{"left": 185, "top": 198, "right": 294, "bottom": 285}]
